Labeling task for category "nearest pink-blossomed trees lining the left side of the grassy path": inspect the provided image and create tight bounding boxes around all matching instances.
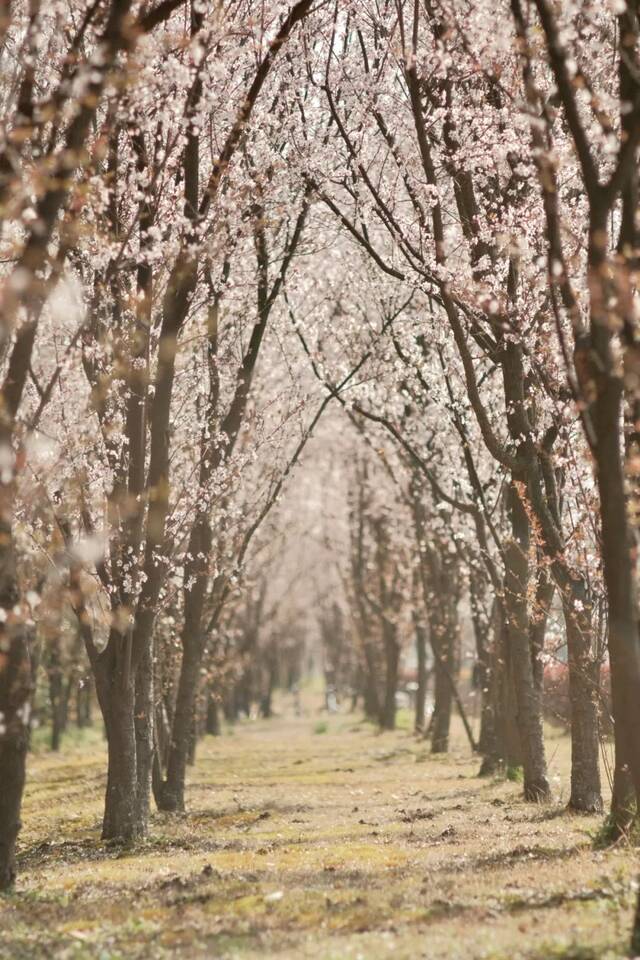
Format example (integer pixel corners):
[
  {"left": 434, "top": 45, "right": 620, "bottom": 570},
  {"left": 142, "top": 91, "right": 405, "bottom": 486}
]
[{"left": 0, "top": 2, "right": 320, "bottom": 886}]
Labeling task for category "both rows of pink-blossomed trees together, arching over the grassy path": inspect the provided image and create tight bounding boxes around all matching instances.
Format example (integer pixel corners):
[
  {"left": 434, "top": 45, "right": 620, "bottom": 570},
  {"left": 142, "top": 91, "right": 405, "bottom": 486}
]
[{"left": 0, "top": 0, "right": 640, "bottom": 947}]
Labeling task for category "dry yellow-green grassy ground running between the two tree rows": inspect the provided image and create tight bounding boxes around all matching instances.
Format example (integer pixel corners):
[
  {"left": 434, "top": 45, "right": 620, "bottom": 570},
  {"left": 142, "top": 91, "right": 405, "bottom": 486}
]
[{"left": 0, "top": 701, "right": 636, "bottom": 960}]
